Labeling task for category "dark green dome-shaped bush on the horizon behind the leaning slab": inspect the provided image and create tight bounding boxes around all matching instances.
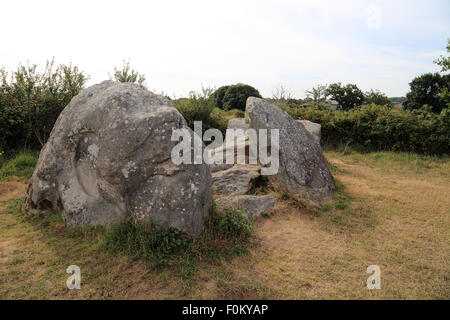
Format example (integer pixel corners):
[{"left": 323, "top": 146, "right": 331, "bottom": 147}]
[{"left": 211, "top": 83, "right": 261, "bottom": 111}]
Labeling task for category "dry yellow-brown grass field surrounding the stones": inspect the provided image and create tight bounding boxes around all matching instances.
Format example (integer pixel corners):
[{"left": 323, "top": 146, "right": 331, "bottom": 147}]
[{"left": 0, "top": 152, "right": 450, "bottom": 299}]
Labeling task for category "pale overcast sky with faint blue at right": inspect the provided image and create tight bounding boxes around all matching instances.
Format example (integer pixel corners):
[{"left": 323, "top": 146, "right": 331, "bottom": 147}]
[{"left": 0, "top": 0, "right": 450, "bottom": 97}]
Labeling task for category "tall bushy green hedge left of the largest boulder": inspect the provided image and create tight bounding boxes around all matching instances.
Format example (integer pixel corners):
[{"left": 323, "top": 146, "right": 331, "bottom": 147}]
[{"left": 0, "top": 60, "right": 87, "bottom": 151}]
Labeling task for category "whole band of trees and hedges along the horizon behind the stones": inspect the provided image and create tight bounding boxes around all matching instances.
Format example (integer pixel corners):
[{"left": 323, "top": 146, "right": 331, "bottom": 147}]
[{"left": 0, "top": 54, "right": 450, "bottom": 154}]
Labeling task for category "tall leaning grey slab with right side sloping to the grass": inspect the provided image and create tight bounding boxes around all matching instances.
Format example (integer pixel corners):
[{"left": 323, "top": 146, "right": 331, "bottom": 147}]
[{"left": 246, "top": 97, "right": 335, "bottom": 201}]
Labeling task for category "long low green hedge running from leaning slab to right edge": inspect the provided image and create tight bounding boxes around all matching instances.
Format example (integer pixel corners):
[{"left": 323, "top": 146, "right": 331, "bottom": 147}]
[{"left": 285, "top": 104, "right": 450, "bottom": 154}]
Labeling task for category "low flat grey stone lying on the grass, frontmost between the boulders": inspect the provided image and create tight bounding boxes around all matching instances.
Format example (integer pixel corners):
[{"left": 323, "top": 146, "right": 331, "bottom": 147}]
[{"left": 216, "top": 195, "right": 277, "bottom": 219}]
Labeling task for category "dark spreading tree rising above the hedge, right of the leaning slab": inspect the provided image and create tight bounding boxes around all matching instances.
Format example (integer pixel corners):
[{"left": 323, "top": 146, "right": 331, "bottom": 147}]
[{"left": 325, "top": 82, "right": 364, "bottom": 110}]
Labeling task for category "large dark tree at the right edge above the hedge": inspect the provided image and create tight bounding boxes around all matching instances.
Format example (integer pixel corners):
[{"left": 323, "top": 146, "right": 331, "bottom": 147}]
[{"left": 403, "top": 73, "right": 450, "bottom": 113}]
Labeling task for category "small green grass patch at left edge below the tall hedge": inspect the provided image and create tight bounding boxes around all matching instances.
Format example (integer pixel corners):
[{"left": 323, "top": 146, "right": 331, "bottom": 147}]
[{"left": 0, "top": 150, "right": 39, "bottom": 181}]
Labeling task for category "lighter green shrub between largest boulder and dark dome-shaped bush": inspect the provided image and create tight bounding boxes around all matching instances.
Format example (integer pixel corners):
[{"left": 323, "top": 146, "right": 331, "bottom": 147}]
[{"left": 173, "top": 88, "right": 228, "bottom": 136}]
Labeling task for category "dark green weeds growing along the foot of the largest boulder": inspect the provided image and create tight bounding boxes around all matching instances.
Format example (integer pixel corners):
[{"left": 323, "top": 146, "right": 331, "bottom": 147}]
[{"left": 101, "top": 206, "right": 253, "bottom": 268}]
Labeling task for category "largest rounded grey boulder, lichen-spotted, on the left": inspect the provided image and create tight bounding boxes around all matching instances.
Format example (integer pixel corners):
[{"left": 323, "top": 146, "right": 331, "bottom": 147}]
[{"left": 24, "top": 81, "right": 212, "bottom": 236}]
